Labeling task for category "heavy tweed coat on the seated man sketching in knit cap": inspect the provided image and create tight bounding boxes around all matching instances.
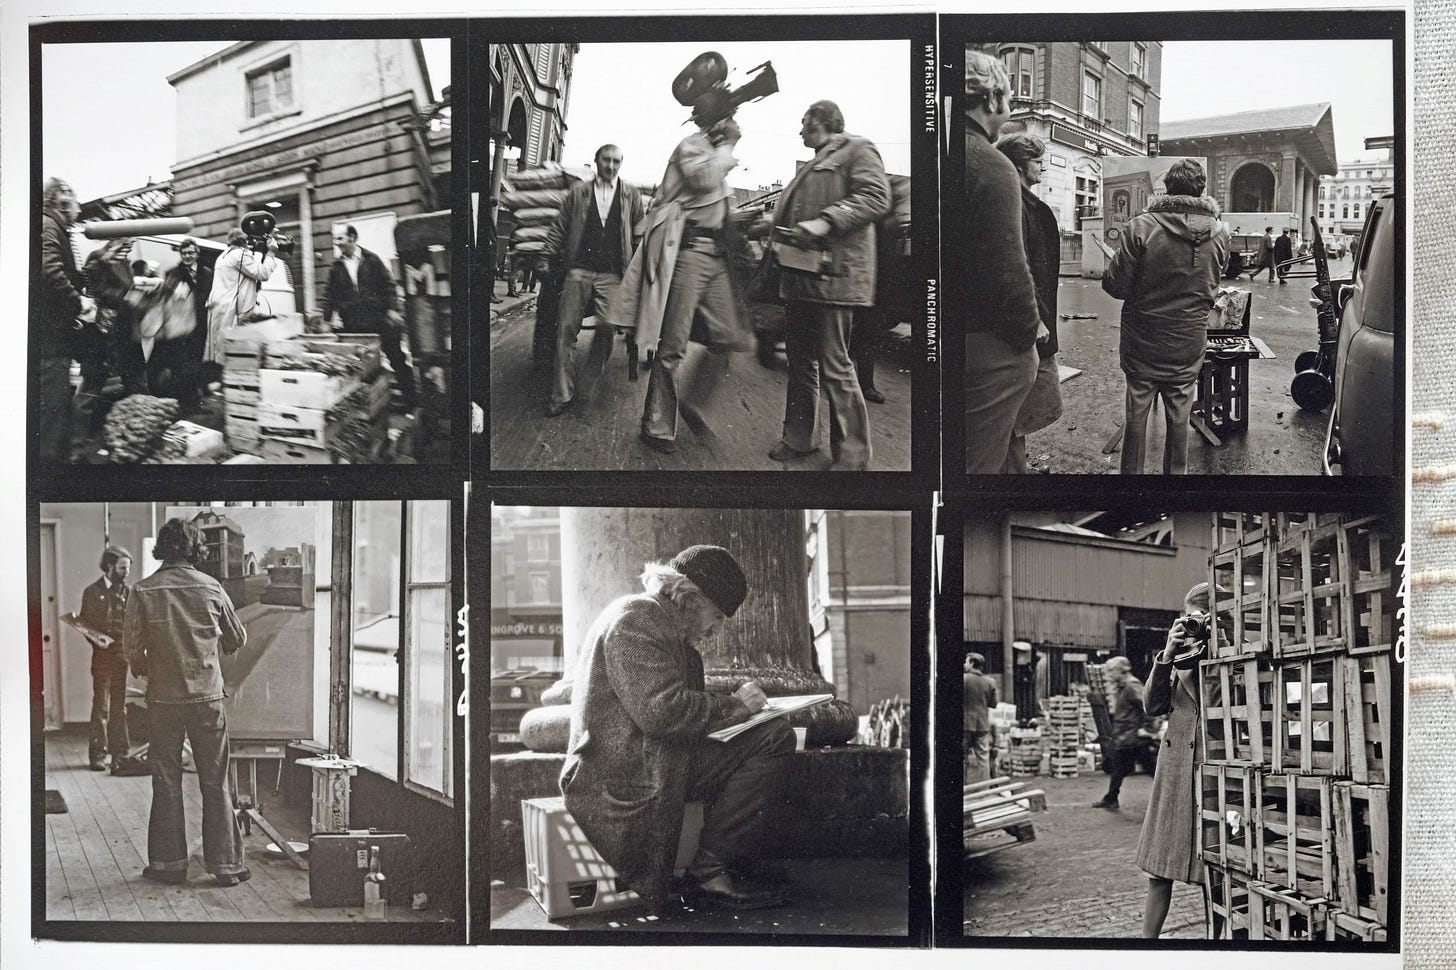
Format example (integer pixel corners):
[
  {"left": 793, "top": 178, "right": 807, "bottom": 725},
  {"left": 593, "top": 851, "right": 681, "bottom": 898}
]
[{"left": 561, "top": 593, "right": 750, "bottom": 909}]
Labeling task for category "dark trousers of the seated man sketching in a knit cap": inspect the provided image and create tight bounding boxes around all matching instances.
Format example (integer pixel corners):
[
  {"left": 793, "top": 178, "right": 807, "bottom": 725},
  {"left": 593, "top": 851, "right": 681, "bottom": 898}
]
[{"left": 687, "top": 718, "right": 794, "bottom": 878}]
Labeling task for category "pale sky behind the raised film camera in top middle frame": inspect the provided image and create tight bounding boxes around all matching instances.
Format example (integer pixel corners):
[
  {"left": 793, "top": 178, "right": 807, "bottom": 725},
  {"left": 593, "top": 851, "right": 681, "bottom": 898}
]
[{"left": 562, "top": 41, "right": 911, "bottom": 188}]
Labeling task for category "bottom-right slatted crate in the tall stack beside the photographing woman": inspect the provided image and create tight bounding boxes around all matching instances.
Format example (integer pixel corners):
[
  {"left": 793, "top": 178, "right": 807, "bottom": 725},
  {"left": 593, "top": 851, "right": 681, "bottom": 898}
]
[{"left": 1332, "top": 782, "right": 1390, "bottom": 926}]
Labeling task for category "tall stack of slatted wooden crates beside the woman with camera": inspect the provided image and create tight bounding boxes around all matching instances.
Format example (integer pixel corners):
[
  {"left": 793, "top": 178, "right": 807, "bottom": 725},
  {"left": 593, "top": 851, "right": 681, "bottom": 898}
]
[{"left": 1200, "top": 514, "right": 1396, "bottom": 941}]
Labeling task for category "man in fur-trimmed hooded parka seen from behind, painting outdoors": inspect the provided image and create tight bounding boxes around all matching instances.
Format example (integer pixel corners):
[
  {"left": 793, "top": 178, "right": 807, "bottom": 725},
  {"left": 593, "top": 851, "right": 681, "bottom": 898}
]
[{"left": 1102, "top": 159, "right": 1229, "bottom": 475}]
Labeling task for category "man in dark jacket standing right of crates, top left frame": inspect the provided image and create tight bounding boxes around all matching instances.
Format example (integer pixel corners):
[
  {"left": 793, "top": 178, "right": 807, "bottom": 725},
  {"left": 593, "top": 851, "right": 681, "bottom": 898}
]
[{"left": 313, "top": 226, "right": 418, "bottom": 411}]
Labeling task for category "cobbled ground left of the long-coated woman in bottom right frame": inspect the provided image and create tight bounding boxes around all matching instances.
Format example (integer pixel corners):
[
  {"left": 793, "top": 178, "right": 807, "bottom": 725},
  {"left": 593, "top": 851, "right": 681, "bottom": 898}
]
[{"left": 964, "top": 772, "right": 1204, "bottom": 939}]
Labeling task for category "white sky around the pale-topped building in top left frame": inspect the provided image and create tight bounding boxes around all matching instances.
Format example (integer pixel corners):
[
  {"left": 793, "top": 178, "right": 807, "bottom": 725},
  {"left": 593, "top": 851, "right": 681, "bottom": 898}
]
[{"left": 41, "top": 38, "right": 450, "bottom": 201}]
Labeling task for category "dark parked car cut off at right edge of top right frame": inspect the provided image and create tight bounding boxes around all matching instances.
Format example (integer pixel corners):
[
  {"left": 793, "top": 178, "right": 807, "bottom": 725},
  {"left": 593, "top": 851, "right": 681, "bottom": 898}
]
[{"left": 1324, "top": 194, "right": 1401, "bottom": 475}]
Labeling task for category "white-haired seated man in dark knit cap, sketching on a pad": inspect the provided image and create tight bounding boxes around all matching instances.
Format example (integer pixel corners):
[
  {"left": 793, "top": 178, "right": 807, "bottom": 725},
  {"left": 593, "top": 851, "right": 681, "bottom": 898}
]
[{"left": 561, "top": 546, "right": 795, "bottom": 912}]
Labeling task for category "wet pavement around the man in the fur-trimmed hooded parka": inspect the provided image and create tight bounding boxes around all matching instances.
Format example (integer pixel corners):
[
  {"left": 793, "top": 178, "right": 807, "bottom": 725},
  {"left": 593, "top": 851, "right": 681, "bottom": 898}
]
[{"left": 1001, "top": 259, "right": 1350, "bottom": 475}]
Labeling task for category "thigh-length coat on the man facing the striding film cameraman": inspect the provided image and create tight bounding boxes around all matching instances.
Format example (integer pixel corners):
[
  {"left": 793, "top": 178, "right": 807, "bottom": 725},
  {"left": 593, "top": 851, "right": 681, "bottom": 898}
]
[{"left": 773, "top": 133, "right": 891, "bottom": 306}]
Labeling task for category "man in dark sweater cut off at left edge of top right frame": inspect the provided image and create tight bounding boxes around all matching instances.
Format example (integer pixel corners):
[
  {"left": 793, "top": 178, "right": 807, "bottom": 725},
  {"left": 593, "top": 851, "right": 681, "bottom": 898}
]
[{"left": 964, "top": 51, "right": 1041, "bottom": 475}]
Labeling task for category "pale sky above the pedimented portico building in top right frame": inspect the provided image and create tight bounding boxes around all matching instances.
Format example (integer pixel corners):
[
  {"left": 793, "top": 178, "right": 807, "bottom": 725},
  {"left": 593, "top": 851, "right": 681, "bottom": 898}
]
[{"left": 1162, "top": 41, "right": 1395, "bottom": 162}]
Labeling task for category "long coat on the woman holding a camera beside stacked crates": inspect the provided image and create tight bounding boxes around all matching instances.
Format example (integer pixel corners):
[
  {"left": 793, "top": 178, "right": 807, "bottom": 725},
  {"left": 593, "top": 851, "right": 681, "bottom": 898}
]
[{"left": 1136, "top": 660, "right": 1204, "bottom": 883}]
